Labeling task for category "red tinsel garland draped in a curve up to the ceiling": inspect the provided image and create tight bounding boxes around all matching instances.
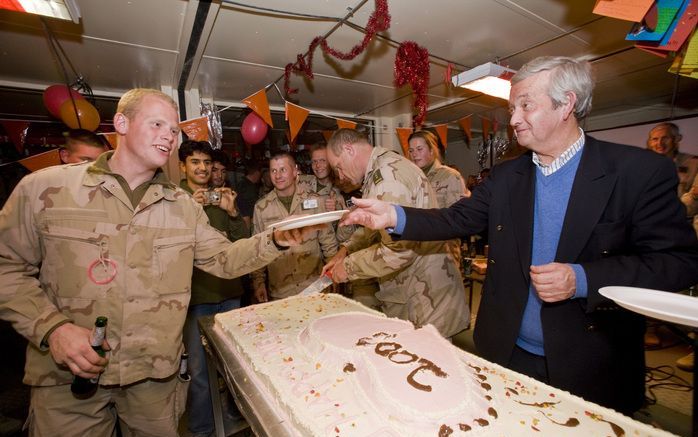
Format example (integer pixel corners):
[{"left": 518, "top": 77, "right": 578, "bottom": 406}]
[{"left": 284, "top": 0, "right": 390, "bottom": 97}]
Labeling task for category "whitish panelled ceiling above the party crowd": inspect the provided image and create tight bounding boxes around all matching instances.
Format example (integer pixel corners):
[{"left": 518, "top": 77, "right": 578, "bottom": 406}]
[{"left": 0, "top": 0, "right": 698, "bottom": 128}]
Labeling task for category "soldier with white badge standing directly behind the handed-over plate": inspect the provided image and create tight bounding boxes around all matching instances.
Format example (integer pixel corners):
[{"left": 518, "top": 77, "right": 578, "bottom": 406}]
[{"left": 251, "top": 153, "right": 337, "bottom": 302}]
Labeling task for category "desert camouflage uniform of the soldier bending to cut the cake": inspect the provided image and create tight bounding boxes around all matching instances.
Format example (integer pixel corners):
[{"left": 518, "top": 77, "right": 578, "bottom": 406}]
[{"left": 344, "top": 147, "right": 469, "bottom": 337}]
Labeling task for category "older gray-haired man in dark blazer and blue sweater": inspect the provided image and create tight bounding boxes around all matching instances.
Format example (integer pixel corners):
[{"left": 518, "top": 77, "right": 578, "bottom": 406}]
[{"left": 344, "top": 57, "right": 698, "bottom": 414}]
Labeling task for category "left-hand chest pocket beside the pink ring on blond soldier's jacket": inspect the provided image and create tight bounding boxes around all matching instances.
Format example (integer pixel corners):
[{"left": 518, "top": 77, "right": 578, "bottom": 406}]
[{"left": 38, "top": 208, "right": 109, "bottom": 299}]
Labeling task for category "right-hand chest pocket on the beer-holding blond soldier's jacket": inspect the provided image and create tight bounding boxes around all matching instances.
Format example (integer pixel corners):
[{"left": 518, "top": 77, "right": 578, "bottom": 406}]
[{"left": 153, "top": 235, "right": 194, "bottom": 294}]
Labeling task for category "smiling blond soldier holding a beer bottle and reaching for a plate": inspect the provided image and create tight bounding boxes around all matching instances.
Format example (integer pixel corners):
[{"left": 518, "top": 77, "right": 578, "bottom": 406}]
[{"left": 0, "top": 89, "right": 314, "bottom": 436}]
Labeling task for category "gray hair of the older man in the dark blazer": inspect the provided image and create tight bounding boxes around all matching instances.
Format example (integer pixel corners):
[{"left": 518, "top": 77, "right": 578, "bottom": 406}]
[{"left": 511, "top": 56, "right": 594, "bottom": 120}]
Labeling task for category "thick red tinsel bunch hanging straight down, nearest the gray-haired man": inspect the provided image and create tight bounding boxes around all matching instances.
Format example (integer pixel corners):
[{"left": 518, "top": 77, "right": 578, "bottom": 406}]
[{"left": 395, "top": 41, "right": 429, "bottom": 126}]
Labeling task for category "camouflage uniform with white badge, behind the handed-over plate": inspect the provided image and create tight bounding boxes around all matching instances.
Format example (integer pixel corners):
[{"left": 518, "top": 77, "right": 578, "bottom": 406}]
[{"left": 251, "top": 187, "right": 337, "bottom": 299}]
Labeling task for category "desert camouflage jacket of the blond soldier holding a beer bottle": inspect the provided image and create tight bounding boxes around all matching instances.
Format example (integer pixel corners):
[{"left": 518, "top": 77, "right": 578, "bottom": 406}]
[{"left": 0, "top": 153, "right": 280, "bottom": 386}]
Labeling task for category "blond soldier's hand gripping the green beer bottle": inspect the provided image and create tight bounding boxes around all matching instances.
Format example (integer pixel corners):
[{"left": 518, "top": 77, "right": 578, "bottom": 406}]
[{"left": 47, "top": 323, "right": 111, "bottom": 378}]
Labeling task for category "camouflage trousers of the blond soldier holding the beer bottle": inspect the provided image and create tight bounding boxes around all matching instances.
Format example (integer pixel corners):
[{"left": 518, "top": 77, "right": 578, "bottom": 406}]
[{"left": 25, "top": 376, "right": 189, "bottom": 437}]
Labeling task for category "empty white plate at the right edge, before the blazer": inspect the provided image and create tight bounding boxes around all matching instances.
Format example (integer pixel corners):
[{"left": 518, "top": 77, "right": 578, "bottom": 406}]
[{"left": 599, "top": 287, "right": 698, "bottom": 327}]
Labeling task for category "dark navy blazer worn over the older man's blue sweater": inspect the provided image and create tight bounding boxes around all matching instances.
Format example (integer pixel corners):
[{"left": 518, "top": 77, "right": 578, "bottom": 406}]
[{"left": 400, "top": 137, "right": 698, "bottom": 413}]
